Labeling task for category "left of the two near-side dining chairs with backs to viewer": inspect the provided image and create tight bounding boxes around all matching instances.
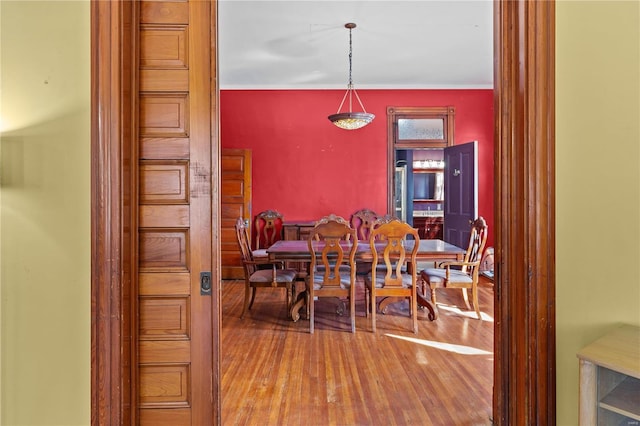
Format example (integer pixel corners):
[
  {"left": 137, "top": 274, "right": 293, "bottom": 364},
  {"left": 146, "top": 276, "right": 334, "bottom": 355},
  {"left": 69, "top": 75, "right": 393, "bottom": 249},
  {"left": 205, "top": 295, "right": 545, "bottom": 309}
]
[{"left": 305, "top": 216, "right": 358, "bottom": 334}]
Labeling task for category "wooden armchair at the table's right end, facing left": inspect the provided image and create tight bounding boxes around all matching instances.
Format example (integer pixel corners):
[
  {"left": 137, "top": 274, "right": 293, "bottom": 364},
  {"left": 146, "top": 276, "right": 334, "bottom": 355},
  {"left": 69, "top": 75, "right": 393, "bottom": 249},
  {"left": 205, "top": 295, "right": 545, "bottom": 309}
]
[{"left": 420, "top": 216, "right": 488, "bottom": 321}]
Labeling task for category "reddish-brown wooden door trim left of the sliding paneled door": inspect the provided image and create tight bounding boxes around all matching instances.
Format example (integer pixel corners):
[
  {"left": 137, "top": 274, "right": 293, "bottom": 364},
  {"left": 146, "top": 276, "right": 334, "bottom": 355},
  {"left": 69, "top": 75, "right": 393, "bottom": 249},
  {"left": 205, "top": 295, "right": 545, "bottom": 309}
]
[{"left": 91, "top": 1, "right": 137, "bottom": 425}]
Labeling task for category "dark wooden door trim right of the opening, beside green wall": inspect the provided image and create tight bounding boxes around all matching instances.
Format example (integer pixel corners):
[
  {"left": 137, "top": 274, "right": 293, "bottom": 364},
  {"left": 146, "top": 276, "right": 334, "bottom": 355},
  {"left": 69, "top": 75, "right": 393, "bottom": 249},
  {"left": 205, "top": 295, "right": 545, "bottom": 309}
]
[{"left": 494, "top": 1, "right": 556, "bottom": 425}]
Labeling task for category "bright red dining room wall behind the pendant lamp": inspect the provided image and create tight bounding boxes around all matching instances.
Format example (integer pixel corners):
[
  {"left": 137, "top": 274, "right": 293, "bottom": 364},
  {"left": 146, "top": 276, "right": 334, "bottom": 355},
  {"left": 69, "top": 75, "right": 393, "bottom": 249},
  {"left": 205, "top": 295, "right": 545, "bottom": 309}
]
[{"left": 220, "top": 90, "right": 494, "bottom": 245}]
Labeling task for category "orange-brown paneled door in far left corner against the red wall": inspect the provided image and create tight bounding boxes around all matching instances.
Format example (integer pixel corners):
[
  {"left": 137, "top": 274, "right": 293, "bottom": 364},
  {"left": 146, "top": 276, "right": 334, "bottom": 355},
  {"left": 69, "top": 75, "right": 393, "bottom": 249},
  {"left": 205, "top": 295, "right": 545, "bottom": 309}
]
[{"left": 220, "top": 149, "right": 251, "bottom": 279}]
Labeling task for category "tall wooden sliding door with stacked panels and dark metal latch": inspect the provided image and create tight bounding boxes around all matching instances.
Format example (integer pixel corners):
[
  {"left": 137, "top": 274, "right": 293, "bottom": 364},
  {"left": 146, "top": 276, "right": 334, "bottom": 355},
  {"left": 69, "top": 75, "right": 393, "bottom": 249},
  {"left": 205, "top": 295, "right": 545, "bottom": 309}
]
[{"left": 135, "top": 1, "right": 214, "bottom": 426}]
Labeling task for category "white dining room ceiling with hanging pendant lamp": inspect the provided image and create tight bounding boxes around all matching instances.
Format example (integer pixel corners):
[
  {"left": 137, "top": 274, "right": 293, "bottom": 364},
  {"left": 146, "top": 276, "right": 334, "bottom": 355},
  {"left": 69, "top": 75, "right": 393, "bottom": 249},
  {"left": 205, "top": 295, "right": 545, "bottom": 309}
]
[{"left": 218, "top": 0, "right": 493, "bottom": 90}]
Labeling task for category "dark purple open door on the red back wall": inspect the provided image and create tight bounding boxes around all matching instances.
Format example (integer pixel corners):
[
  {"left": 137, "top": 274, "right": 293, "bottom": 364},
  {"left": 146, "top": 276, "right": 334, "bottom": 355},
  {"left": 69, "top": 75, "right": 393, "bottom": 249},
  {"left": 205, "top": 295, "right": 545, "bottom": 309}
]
[{"left": 444, "top": 141, "right": 478, "bottom": 248}]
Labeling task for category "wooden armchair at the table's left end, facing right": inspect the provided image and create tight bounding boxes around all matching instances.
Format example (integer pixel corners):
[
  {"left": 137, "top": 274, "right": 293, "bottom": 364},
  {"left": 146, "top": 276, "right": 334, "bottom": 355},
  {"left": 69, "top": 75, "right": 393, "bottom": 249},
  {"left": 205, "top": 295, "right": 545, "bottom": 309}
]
[{"left": 235, "top": 218, "right": 297, "bottom": 318}]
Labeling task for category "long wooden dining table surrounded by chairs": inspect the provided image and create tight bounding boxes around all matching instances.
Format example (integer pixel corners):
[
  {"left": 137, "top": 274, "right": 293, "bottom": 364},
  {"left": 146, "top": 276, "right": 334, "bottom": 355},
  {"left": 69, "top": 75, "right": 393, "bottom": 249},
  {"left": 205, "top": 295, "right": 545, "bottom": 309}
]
[{"left": 267, "top": 239, "right": 466, "bottom": 321}]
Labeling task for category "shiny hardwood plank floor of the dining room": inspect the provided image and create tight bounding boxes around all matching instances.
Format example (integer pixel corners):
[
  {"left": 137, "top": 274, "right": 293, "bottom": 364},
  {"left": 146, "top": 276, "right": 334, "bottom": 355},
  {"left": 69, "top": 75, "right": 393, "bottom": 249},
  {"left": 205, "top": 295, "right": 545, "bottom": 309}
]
[{"left": 221, "top": 280, "right": 494, "bottom": 425}]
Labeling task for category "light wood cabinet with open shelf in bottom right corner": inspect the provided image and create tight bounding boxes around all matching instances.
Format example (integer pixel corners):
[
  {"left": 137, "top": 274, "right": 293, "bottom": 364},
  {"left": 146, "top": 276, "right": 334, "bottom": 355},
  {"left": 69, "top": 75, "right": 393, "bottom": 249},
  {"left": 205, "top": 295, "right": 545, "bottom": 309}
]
[{"left": 578, "top": 325, "right": 640, "bottom": 426}]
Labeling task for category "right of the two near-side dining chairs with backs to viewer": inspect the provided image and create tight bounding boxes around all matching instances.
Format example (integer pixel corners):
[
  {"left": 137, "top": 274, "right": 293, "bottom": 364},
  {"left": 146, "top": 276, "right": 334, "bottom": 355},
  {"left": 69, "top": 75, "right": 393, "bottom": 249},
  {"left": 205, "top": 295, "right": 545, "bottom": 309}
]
[{"left": 364, "top": 217, "right": 420, "bottom": 333}]
